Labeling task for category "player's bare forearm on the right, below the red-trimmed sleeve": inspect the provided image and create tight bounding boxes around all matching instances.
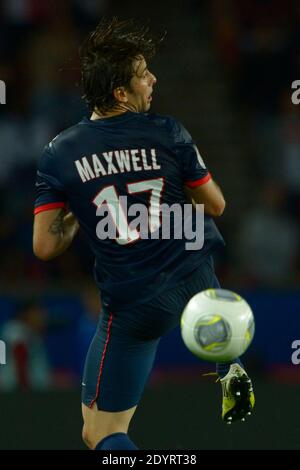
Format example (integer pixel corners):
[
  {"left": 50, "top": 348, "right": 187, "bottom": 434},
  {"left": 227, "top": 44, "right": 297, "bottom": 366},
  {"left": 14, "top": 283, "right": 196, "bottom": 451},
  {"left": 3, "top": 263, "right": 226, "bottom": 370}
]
[{"left": 185, "top": 179, "right": 226, "bottom": 217}]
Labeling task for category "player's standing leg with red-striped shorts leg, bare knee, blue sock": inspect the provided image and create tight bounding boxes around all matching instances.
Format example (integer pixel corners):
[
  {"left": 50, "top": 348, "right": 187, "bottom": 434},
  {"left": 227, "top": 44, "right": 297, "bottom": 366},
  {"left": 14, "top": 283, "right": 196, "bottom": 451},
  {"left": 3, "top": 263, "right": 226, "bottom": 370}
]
[{"left": 82, "top": 312, "right": 159, "bottom": 450}]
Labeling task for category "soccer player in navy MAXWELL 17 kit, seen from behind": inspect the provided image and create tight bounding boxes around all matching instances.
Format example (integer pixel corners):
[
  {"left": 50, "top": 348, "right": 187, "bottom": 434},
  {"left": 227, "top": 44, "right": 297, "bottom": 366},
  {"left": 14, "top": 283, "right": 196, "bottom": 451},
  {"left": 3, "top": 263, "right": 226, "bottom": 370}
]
[{"left": 33, "top": 19, "right": 254, "bottom": 450}]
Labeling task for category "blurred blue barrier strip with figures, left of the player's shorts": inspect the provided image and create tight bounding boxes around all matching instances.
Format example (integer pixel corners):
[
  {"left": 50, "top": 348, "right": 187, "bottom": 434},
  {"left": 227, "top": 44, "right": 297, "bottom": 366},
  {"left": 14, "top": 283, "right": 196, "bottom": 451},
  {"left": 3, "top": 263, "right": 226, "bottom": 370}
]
[{"left": 0, "top": 283, "right": 101, "bottom": 392}]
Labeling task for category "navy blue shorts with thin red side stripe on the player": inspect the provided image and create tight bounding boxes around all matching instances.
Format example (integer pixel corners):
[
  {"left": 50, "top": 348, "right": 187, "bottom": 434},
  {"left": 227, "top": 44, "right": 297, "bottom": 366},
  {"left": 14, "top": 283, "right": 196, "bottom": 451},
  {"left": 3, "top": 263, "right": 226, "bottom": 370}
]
[{"left": 82, "top": 257, "right": 220, "bottom": 412}]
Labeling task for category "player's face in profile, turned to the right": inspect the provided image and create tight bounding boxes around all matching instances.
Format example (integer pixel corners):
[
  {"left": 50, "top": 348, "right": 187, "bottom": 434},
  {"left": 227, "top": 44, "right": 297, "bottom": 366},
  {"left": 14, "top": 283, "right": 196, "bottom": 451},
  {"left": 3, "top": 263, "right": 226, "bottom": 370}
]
[{"left": 126, "top": 57, "right": 157, "bottom": 113}]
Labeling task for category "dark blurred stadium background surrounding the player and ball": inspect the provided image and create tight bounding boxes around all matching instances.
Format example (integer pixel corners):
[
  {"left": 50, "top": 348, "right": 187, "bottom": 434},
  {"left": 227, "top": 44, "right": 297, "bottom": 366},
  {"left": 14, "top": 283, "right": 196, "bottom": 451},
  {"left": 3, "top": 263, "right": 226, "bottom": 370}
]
[{"left": 0, "top": 0, "right": 300, "bottom": 449}]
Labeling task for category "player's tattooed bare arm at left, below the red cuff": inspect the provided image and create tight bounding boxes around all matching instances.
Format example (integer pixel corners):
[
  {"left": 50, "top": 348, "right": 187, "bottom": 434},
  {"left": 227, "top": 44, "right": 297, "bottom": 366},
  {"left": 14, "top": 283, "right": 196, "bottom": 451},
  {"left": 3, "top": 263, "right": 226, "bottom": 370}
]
[{"left": 33, "top": 208, "right": 79, "bottom": 261}]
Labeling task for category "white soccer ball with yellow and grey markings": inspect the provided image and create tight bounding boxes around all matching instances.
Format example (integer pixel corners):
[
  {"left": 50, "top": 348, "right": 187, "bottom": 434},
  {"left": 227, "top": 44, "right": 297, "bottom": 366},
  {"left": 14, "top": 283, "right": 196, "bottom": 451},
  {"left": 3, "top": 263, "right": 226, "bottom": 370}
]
[{"left": 181, "top": 289, "right": 255, "bottom": 362}]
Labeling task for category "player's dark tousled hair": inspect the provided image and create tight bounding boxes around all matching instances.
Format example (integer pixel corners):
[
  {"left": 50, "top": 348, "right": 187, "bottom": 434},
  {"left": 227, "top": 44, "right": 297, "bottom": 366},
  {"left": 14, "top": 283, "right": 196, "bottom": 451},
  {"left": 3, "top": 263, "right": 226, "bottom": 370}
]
[{"left": 80, "top": 18, "right": 164, "bottom": 114}]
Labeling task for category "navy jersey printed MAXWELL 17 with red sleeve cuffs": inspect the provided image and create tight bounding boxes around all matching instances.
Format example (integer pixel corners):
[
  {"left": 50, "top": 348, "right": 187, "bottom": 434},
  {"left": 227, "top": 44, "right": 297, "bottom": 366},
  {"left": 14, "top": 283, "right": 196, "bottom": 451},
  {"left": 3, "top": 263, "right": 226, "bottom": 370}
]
[{"left": 35, "top": 111, "right": 224, "bottom": 308}]
